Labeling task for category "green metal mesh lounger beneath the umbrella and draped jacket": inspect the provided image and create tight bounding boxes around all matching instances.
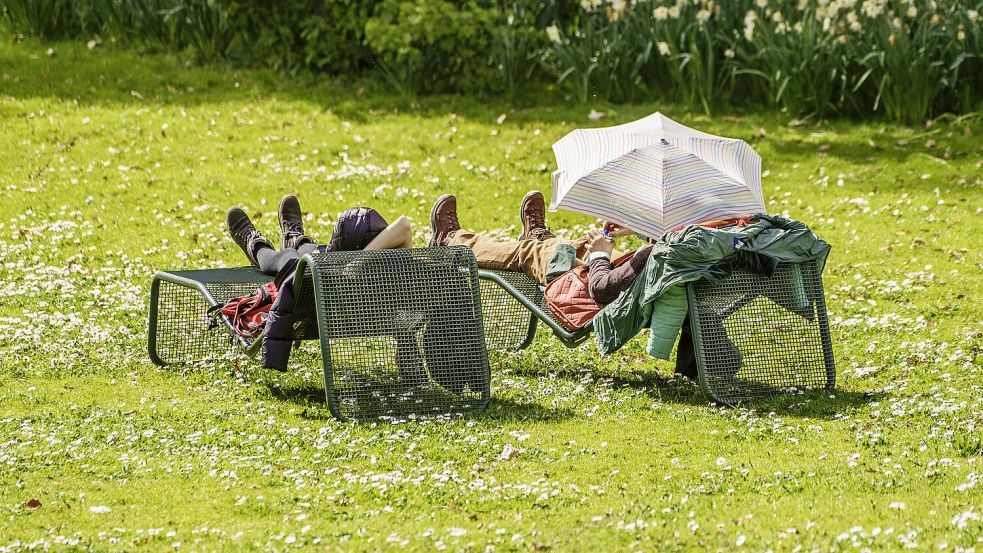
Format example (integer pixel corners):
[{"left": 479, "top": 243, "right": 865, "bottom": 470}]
[{"left": 478, "top": 261, "right": 836, "bottom": 404}]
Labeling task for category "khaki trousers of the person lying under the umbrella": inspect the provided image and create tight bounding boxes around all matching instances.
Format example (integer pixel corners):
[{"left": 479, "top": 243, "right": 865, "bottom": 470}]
[{"left": 448, "top": 229, "right": 587, "bottom": 285}]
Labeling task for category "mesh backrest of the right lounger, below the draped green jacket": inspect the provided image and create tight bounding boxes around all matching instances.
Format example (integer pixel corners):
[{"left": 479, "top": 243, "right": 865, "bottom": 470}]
[{"left": 687, "top": 261, "right": 836, "bottom": 403}]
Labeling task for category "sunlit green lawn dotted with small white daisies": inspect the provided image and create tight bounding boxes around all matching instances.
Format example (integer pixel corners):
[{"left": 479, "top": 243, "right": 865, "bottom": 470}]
[{"left": 0, "top": 38, "right": 983, "bottom": 551}]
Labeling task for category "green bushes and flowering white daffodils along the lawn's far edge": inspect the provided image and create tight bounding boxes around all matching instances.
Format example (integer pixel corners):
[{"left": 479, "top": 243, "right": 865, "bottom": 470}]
[{"left": 0, "top": 0, "right": 983, "bottom": 123}]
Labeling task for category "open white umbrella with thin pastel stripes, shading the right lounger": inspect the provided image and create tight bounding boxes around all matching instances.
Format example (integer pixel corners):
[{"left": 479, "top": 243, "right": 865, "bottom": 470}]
[{"left": 550, "top": 112, "right": 765, "bottom": 238}]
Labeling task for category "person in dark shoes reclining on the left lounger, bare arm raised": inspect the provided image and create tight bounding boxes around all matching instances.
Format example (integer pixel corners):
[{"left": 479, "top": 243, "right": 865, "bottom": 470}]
[{"left": 226, "top": 195, "right": 413, "bottom": 276}]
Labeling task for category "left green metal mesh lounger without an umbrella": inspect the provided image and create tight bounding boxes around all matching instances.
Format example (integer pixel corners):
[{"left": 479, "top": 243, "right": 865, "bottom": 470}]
[{"left": 148, "top": 247, "right": 490, "bottom": 420}]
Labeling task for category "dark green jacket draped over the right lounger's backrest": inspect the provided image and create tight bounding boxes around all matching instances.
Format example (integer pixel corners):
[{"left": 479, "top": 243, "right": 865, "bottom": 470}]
[{"left": 593, "top": 215, "right": 830, "bottom": 359}]
